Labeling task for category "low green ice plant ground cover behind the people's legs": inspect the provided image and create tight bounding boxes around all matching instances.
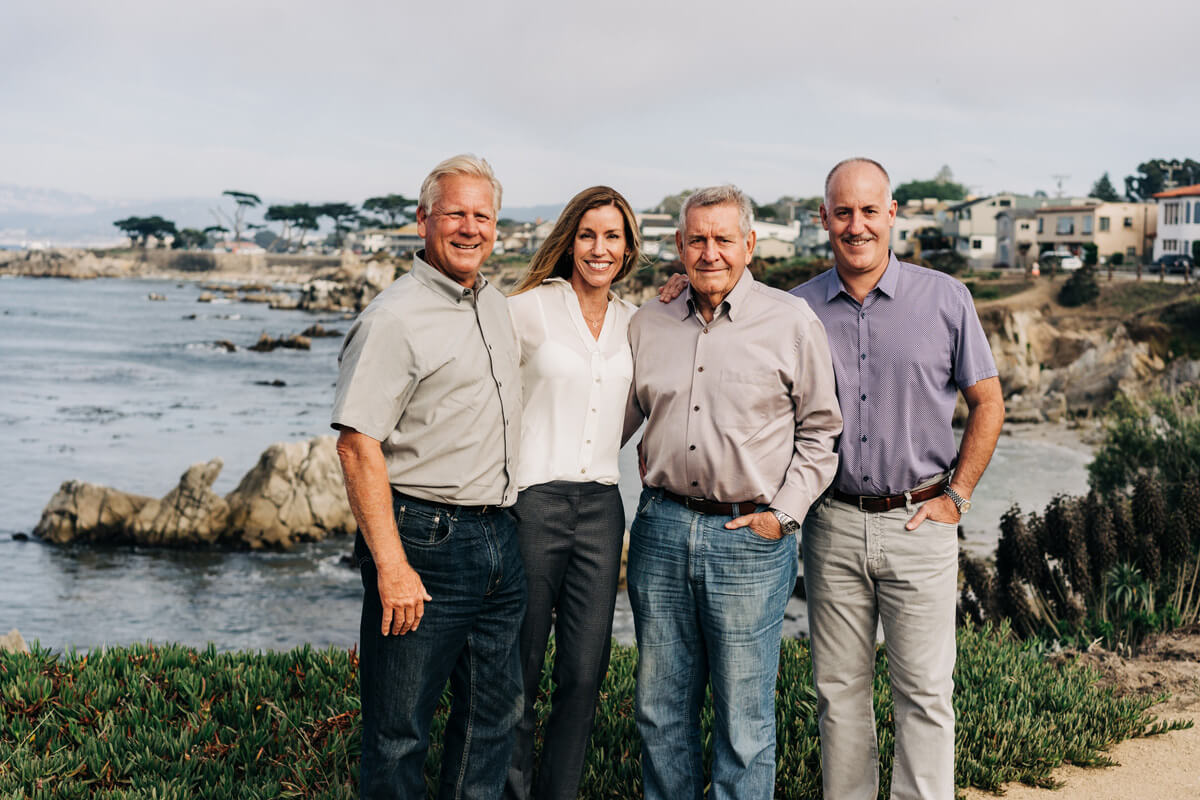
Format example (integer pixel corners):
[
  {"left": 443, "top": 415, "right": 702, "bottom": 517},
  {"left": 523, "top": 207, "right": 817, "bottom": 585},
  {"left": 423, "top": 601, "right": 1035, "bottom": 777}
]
[{"left": 0, "top": 624, "right": 1190, "bottom": 799}]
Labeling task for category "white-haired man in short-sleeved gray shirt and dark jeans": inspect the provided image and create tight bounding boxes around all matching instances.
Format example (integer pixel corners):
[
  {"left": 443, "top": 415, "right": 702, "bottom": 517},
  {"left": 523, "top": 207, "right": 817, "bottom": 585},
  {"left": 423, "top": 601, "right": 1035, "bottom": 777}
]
[{"left": 332, "top": 156, "right": 526, "bottom": 800}]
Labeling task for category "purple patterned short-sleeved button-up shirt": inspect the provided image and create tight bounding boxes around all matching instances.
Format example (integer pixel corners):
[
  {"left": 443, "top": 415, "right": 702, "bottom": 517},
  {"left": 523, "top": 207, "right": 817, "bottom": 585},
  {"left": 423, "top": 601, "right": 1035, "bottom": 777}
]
[{"left": 792, "top": 254, "right": 998, "bottom": 495}]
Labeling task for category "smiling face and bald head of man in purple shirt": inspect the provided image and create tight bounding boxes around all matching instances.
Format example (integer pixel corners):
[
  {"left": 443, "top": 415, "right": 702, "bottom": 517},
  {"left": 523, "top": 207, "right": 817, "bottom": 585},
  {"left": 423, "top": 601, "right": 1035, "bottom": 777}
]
[{"left": 821, "top": 162, "right": 896, "bottom": 277}]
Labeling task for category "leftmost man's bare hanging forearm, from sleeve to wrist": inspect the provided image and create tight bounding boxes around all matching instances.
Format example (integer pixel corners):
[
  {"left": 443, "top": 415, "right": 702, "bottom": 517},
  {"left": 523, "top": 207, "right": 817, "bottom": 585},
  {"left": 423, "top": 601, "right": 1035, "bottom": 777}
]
[{"left": 337, "top": 431, "right": 408, "bottom": 566}]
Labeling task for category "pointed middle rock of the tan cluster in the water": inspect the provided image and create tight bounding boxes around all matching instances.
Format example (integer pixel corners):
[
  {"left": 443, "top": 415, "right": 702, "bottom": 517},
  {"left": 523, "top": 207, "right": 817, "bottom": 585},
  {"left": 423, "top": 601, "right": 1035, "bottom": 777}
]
[{"left": 127, "top": 458, "right": 229, "bottom": 546}]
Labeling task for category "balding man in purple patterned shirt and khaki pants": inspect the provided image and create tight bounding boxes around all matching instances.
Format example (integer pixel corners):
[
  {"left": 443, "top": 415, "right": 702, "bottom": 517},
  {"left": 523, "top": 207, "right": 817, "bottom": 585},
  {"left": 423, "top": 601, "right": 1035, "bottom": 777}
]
[{"left": 792, "top": 158, "right": 1004, "bottom": 800}]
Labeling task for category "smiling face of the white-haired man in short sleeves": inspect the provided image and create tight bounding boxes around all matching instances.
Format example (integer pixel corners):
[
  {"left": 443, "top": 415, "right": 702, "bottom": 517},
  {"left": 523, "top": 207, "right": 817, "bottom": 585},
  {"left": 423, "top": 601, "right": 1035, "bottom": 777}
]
[{"left": 416, "top": 175, "right": 496, "bottom": 289}]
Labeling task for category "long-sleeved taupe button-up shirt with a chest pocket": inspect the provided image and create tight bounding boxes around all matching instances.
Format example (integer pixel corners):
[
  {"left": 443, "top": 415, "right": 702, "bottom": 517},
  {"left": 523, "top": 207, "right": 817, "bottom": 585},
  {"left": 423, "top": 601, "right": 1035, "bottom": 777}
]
[{"left": 624, "top": 270, "right": 841, "bottom": 521}]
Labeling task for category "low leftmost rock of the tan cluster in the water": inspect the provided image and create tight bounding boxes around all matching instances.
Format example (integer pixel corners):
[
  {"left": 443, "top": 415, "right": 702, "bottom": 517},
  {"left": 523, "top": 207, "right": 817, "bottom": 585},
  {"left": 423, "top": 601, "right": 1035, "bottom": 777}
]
[{"left": 34, "top": 481, "right": 156, "bottom": 545}]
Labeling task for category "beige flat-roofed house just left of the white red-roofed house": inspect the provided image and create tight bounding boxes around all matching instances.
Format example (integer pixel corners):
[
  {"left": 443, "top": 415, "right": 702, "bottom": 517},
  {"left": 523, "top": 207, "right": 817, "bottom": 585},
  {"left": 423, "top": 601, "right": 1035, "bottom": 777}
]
[{"left": 1034, "top": 198, "right": 1158, "bottom": 260}]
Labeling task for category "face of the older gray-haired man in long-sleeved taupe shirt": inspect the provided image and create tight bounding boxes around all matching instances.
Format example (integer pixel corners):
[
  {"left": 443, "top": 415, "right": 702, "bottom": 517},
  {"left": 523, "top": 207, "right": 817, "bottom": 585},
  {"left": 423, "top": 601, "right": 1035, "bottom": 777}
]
[{"left": 676, "top": 203, "right": 756, "bottom": 319}]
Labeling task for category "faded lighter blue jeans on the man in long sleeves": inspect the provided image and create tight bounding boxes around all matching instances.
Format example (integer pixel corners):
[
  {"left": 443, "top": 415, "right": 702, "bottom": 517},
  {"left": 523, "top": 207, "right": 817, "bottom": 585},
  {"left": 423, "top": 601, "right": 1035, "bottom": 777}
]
[{"left": 628, "top": 489, "right": 797, "bottom": 800}]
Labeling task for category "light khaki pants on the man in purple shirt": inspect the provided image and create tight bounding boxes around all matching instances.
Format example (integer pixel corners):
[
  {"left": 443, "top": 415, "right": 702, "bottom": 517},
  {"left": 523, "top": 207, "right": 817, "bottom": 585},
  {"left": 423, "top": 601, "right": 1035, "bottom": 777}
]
[{"left": 803, "top": 499, "right": 958, "bottom": 800}]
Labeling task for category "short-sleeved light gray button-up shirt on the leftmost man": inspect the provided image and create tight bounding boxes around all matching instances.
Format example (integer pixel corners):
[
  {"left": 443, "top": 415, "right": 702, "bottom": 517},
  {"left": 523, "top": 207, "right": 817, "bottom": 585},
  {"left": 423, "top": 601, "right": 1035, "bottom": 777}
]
[{"left": 332, "top": 251, "right": 521, "bottom": 505}]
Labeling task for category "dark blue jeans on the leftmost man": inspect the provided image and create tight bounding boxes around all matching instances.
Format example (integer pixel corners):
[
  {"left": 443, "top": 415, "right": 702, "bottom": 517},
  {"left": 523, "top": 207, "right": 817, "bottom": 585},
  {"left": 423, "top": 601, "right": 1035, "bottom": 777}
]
[{"left": 354, "top": 497, "right": 526, "bottom": 800}]
